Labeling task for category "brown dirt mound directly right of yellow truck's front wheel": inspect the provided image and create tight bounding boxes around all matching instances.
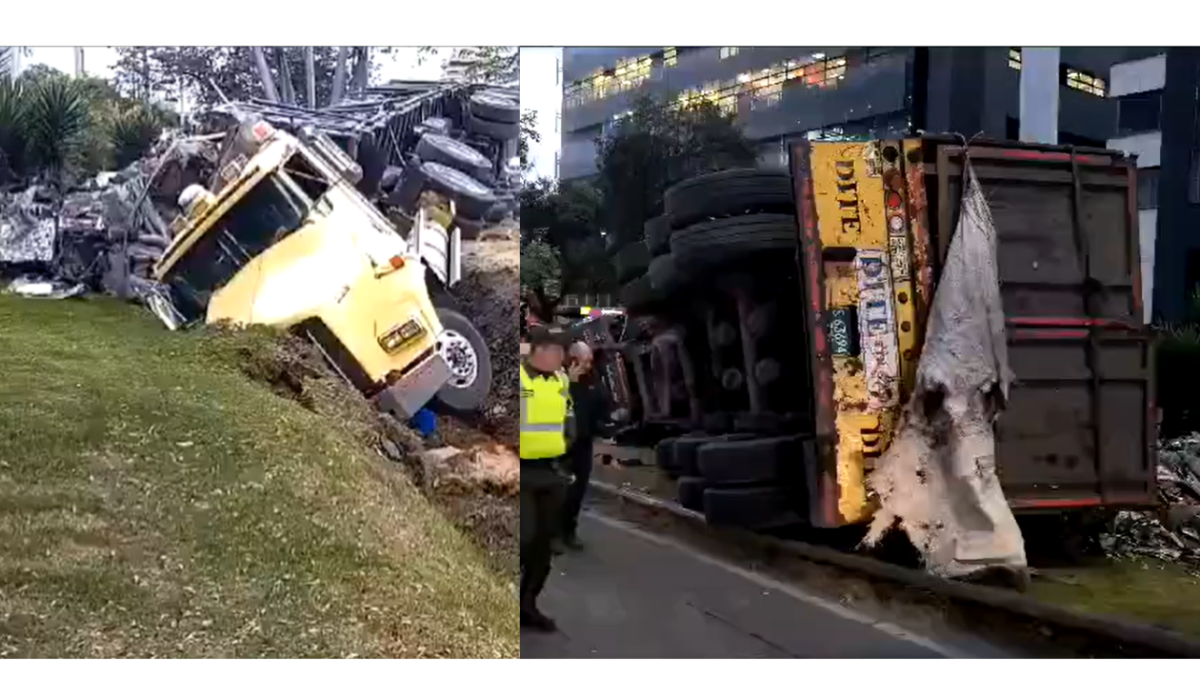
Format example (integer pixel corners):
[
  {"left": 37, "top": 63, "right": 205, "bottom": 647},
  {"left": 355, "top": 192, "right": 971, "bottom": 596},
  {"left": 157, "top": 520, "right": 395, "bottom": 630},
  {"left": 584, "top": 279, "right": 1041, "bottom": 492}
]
[{"left": 454, "top": 240, "right": 521, "bottom": 447}]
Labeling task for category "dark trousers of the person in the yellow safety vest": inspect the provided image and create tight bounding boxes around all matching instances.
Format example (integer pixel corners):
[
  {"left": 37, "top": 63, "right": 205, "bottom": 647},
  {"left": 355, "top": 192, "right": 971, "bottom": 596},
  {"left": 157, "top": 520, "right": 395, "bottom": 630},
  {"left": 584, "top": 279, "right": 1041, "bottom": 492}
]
[{"left": 521, "top": 460, "right": 569, "bottom": 610}]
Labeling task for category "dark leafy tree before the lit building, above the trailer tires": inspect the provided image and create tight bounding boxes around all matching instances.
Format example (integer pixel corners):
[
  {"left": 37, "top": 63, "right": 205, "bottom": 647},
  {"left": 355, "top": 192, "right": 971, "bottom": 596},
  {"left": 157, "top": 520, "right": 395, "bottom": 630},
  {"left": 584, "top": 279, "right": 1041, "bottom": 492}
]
[{"left": 596, "top": 98, "right": 757, "bottom": 248}]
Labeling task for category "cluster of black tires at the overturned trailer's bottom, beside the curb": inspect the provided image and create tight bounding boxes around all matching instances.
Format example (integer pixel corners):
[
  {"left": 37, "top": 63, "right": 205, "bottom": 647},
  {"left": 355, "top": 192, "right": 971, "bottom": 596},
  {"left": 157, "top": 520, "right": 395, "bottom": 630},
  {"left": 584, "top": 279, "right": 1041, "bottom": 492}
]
[{"left": 655, "top": 434, "right": 816, "bottom": 530}]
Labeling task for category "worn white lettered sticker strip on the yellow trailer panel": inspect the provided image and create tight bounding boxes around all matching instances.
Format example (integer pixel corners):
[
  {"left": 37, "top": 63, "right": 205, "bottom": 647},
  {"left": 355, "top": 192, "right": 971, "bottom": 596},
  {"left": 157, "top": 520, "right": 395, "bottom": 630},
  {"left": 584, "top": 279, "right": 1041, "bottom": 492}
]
[{"left": 854, "top": 250, "right": 900, "bottom": 412}]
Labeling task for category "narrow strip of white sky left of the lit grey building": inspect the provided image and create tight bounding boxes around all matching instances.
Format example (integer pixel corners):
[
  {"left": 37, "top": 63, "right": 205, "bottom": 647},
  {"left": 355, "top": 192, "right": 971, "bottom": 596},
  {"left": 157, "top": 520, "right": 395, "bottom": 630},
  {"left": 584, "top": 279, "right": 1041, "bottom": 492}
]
[{"left": 521, "top": 47, "right": 563, "bottom": 178}]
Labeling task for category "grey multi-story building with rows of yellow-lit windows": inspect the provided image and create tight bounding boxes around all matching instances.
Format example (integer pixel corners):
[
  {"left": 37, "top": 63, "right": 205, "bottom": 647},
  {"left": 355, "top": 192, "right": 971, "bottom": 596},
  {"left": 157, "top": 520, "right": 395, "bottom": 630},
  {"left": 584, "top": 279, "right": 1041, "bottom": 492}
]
[{"left": 559, "top": 47, "right": 1153, "bottom": 180}]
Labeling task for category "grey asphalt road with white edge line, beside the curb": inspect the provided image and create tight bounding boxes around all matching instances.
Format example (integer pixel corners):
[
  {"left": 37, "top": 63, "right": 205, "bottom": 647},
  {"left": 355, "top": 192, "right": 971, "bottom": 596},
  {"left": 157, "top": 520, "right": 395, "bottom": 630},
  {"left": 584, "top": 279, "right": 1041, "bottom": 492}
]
[{"left": 521, "top": 512, "right": 1003, "bottom": 658}]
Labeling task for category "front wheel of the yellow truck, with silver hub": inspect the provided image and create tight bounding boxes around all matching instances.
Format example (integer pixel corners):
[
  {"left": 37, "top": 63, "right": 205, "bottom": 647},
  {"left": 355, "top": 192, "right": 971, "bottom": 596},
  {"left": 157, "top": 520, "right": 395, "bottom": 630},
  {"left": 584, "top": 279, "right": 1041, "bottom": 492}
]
[{"left": 436, "top": 307, "right": 492, "bottom": 412}]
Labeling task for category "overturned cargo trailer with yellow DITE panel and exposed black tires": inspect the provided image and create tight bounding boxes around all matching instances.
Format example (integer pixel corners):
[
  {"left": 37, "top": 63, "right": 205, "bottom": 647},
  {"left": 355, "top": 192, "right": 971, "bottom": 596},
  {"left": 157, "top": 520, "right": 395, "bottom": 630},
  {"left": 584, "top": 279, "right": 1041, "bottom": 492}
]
[{"left": 616, "top": 137, "right": 1156, "bottom": 527}]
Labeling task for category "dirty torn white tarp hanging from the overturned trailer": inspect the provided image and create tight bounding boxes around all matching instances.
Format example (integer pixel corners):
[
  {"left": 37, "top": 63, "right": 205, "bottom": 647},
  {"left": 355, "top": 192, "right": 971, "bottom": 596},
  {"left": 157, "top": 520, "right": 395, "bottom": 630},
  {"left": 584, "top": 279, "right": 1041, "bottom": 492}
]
[{"left": 866, "top": 156, "right": 1026, "bottom": 577}]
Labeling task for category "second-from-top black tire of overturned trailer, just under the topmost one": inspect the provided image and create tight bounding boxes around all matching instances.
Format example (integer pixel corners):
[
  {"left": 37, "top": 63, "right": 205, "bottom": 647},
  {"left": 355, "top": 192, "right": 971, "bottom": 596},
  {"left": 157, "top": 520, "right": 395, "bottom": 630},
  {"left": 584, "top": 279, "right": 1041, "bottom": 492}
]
[{"left": 671, "top": 214, "right": 798, "bottom": 274}]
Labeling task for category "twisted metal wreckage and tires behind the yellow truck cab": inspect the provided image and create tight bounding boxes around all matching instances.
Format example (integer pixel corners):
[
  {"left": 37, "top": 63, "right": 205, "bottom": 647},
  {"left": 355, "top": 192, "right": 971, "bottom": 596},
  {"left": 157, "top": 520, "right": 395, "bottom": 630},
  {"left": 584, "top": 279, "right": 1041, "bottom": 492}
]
[{"left": 0, "top": 82, "right": 520, "bottom": 313}]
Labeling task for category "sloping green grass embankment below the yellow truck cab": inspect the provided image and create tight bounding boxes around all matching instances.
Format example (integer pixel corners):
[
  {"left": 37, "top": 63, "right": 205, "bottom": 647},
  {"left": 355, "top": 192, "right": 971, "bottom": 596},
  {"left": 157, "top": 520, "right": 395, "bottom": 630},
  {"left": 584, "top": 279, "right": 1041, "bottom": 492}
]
[{"left": 0, "top": 297, "right": 520, "bottom": 657}]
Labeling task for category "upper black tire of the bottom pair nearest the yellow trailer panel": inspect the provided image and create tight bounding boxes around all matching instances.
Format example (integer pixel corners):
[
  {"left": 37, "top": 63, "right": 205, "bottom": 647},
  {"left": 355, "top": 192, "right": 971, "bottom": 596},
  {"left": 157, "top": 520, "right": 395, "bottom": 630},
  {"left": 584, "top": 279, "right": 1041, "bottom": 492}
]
[{"left": 696, "top": 436, "right": 809, "bottom": 483}]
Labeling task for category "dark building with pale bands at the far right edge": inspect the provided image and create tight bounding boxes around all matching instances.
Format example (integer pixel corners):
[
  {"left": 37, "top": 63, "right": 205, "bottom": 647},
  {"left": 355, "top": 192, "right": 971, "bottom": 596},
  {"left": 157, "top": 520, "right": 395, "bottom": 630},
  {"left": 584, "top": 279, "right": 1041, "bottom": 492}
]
[{"left": 1109, "top": 47, "right": 1200, "bottom": 321}]
